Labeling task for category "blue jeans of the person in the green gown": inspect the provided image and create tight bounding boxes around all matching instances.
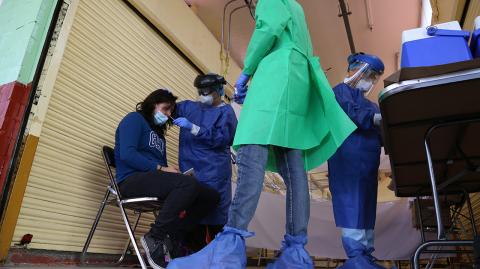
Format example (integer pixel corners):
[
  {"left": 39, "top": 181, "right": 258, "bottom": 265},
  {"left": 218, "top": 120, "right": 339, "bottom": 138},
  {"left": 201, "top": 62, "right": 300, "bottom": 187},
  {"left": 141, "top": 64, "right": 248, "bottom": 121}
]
[{"left": 227, "top": 145, "right": 310, "bottom": 236}]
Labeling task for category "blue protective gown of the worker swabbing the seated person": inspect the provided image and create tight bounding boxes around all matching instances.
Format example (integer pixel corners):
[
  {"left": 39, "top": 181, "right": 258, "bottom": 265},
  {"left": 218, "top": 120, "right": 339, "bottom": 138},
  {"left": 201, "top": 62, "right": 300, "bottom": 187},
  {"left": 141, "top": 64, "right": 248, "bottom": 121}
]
[{"left": 176, "top": 101, "right": 237, "bottom": 225}]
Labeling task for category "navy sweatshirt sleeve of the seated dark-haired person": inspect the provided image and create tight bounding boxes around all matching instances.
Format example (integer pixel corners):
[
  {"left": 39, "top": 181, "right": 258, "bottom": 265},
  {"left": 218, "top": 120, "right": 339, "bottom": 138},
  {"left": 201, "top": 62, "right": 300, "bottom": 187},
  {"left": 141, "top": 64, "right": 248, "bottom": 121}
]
[{"left": 118, "top": 113, "right": 157, "bottom": 172}]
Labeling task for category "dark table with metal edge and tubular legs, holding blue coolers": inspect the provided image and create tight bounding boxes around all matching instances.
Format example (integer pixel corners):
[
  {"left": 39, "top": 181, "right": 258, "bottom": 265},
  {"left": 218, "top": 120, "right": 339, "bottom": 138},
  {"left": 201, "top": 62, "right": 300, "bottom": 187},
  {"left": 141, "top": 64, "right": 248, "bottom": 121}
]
[{"left": 379, "top": 68, "right": 480, "bottom": 269}]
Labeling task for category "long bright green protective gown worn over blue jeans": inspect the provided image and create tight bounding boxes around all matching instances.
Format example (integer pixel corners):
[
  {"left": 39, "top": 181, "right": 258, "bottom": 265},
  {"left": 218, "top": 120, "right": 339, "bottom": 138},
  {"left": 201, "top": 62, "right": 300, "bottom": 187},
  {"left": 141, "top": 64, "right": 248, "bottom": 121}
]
[{"left": 233, "top": 0, "right": 356, "bottom": 171}]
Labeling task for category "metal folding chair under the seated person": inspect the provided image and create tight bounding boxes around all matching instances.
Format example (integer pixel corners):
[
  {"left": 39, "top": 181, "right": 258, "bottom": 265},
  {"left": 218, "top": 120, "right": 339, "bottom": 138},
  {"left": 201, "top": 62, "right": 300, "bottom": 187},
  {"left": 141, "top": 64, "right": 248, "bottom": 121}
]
[{"left": 80, "top": 146, "right": 163, "bottom": 269}]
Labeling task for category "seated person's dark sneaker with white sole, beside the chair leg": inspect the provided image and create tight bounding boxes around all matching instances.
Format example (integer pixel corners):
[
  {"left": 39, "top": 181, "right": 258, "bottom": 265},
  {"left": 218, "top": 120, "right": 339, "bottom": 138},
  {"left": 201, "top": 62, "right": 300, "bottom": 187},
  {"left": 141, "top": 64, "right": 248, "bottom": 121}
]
[{"left": 140, "top": 233, "right": 170, "bottom": 269}]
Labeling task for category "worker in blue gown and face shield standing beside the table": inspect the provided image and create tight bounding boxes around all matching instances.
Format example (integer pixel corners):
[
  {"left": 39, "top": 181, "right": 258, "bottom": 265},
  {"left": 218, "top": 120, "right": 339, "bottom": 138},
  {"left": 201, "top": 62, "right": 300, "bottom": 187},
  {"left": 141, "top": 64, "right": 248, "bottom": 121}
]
[{"left": 328, "top": 53, "right": 384, "bottom": 269}]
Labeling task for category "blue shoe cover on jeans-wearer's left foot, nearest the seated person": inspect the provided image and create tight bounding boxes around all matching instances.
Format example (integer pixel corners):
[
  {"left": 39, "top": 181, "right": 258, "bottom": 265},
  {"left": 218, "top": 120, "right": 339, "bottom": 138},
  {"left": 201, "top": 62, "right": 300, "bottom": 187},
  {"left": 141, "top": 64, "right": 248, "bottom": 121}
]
[{"left": 167, "top": 226, "right": 254, "bottom": 269}]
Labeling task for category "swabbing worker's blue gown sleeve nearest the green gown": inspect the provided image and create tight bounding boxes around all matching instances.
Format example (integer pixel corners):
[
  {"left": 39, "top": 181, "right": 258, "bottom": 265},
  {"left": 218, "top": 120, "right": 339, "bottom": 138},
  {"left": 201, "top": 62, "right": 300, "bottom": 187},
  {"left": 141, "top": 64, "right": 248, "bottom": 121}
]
[{"left": 196, "top": 105, "right": 237, "bottom": 148}]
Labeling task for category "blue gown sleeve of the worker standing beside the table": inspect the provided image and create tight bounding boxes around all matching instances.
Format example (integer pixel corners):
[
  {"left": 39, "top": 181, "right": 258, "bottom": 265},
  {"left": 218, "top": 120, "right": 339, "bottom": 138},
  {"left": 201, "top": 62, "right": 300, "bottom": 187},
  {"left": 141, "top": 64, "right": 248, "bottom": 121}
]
[{"left": 334, "top": 86, "right": 376, "bottom": 130}]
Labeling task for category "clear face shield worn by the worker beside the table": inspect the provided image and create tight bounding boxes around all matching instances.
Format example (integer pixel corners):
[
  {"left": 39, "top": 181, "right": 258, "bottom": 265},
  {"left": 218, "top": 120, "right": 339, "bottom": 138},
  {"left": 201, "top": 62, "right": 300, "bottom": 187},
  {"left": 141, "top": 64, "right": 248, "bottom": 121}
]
[{"left": 343, "top": 62, "right": 382, "bottom": 96}]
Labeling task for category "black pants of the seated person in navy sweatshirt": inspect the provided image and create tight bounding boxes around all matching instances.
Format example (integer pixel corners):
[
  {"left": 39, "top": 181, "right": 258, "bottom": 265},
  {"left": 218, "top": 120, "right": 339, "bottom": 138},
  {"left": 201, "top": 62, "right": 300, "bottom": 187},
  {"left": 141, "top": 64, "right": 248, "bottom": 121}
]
[{"left": 119, "top": 171, "right": 220, "bottom": 240}]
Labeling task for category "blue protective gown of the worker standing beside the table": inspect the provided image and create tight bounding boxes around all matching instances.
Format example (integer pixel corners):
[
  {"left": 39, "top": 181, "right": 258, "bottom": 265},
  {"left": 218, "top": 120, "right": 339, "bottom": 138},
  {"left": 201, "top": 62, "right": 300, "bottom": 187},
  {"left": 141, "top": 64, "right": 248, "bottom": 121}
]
[{"left": 328, "top": 83, "right": 381, "bottom": 229}]
